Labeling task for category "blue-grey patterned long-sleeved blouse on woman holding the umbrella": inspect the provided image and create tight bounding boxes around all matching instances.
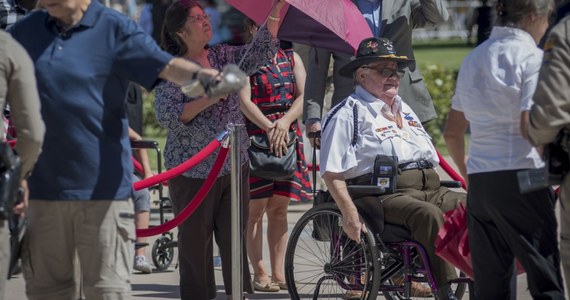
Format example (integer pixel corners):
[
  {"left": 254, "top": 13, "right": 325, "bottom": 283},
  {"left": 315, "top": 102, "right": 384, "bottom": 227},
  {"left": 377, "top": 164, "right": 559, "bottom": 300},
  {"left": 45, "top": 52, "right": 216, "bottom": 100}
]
[{"left": 155, "top": 26, "right": 279, "bottom": 179}]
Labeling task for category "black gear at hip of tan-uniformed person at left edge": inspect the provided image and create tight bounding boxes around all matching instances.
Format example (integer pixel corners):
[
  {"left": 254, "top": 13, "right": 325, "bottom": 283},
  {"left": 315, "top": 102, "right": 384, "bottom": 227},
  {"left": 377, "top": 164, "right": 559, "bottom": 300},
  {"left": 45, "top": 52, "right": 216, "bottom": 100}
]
[{"left": 0, "top": 143, "right": 21, "bottom": 220}]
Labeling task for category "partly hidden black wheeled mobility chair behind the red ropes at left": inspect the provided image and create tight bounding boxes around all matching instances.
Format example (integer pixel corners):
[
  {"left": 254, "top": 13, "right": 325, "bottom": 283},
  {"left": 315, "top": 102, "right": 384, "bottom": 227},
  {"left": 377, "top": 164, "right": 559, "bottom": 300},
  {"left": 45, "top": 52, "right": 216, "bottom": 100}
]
[{"left": 131, "top": 140, "right": 178, "bottom": 271}]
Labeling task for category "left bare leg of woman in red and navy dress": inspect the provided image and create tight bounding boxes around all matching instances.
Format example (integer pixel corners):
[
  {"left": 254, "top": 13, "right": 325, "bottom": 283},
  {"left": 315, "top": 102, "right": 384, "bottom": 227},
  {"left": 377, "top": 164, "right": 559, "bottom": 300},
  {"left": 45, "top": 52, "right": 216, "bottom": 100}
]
[{"left": 246, "top": 198, "right": 270, "bottom": 285}]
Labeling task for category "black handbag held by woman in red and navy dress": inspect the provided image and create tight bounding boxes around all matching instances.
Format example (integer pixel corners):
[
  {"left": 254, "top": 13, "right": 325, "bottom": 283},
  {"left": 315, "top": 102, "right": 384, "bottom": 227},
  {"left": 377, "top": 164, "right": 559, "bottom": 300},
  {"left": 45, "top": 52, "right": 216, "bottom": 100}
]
[{"left": 248, "top": 131, "right": 297, "bottom": 180}]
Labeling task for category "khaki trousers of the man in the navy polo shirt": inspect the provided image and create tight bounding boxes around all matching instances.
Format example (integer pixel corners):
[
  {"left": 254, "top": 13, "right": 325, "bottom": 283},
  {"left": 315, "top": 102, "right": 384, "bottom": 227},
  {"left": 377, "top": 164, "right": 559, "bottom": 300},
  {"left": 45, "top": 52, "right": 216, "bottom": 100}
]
[{"left": 22, "top": 200, "right": 135, "bottom": 300}]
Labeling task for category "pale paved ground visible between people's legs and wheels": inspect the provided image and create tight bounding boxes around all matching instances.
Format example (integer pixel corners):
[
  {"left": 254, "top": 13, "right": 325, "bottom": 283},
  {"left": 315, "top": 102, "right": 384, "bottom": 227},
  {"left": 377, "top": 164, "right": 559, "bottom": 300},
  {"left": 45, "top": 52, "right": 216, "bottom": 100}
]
[{"left": 5, "top": 165, "right": 560, "bottom": 300}]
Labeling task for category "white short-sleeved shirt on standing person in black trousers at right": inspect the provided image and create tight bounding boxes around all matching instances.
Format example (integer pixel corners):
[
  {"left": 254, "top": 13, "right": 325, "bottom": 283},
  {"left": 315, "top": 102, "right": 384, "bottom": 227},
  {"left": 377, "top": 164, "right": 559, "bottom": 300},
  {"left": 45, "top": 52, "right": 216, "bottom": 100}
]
[{"left": 451, "top": 26, "right": 544, "bottom": 174}]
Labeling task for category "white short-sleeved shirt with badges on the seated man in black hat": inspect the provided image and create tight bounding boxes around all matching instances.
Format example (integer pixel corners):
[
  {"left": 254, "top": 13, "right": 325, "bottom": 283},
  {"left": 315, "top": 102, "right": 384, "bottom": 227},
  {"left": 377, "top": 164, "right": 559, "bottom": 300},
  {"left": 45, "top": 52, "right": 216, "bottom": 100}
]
[{"left": 320, "top": 86, "right": 439, "bottom": 179}]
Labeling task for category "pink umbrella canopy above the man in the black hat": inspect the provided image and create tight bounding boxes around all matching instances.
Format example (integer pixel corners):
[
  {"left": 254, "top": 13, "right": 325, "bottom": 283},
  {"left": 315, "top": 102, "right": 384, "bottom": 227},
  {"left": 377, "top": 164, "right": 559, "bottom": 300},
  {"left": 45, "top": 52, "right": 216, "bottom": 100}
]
[{"left": 226, "top": 0, "right": 372, "bottom": 54}]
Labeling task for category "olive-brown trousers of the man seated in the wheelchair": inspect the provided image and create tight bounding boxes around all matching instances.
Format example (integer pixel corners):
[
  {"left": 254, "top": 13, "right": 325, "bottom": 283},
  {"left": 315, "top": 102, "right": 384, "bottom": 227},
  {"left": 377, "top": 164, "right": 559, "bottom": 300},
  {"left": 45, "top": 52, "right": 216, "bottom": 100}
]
[{"left": 355, "top": 169, "right": 466, "bottom": 287}]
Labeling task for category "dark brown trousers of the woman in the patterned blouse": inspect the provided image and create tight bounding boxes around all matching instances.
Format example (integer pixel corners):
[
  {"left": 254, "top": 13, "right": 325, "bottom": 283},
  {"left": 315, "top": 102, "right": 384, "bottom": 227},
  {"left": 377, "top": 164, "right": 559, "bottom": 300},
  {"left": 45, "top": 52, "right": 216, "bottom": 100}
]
[{"left": 168, "top": 165, "right": 253, "bottom": 300}]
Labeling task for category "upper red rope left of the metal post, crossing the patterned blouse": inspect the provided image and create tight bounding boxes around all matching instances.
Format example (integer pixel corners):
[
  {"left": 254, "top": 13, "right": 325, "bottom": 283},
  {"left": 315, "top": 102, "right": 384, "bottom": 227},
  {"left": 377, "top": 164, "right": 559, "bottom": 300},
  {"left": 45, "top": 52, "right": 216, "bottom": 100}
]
[{"left": 133, "top": 139, "right": 221, "bottom": 191}]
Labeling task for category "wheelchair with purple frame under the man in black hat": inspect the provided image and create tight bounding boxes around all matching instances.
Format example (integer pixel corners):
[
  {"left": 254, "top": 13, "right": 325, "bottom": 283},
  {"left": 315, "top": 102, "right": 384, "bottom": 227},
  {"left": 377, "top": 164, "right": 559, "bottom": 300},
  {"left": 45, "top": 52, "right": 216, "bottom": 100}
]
[{"left": 285, "top": 182, "right": 474, "bottom": 300}]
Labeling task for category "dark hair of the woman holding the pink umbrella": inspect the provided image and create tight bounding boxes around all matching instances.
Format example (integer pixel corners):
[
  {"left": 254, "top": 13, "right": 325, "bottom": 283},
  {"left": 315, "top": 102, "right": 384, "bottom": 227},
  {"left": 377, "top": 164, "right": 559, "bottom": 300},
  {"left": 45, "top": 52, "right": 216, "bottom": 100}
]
[{"left": 160, "top": 0, "right": 202, "bottom": 56}]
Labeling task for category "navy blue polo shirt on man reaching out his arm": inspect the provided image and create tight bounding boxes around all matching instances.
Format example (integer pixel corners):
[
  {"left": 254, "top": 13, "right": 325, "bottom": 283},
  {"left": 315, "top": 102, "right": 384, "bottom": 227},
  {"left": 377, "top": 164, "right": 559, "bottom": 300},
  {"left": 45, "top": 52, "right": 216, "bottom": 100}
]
[{"left": 10, "top": 0, "right": 172, "bottom": 200}]
